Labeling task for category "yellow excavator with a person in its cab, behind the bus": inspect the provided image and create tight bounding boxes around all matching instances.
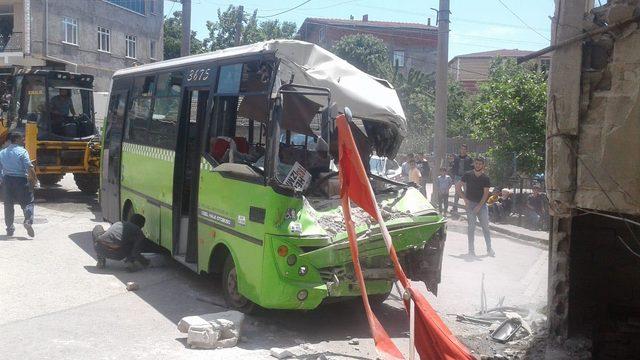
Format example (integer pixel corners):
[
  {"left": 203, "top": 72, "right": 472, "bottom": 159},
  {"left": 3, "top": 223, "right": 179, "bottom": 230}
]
[{"left": 0, "top": 69, "right": 100, "bottom": 194}]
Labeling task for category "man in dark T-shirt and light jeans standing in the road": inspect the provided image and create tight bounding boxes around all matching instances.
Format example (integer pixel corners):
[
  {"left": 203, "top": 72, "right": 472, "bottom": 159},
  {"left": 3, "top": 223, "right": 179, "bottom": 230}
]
[{"left": 456, "top": 157, "right": 496, "bottom": 256}]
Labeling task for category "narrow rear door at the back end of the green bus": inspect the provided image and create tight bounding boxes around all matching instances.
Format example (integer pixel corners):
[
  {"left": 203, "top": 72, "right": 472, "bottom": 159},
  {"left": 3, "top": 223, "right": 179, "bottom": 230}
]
[{"left": 100, "top": 90, "right": 129, "bottom": 223}]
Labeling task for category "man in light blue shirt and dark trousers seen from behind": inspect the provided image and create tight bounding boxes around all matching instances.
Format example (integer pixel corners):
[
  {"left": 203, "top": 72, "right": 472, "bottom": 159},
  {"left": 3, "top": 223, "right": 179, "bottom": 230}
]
[{"left": 0, "top": 132, "right": 38, "bottom": 237}]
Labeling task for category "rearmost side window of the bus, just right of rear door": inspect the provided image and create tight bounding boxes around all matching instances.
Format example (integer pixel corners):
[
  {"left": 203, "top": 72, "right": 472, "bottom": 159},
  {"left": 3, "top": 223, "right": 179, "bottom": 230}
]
[{"left": 125, "top": 75, "right": 155, "bottom": 145}]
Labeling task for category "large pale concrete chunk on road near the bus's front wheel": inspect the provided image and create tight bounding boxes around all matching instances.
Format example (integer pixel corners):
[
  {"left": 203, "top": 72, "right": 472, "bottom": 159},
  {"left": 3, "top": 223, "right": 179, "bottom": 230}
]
[{"left": 178, "top": 310, "right": 244, "bottom": 349}]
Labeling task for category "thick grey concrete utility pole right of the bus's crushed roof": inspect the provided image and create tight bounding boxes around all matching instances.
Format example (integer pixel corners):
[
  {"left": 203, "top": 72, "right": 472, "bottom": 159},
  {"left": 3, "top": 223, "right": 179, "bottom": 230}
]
[{"left": 431, "top": 0, "right": 450, "bottom": 201}]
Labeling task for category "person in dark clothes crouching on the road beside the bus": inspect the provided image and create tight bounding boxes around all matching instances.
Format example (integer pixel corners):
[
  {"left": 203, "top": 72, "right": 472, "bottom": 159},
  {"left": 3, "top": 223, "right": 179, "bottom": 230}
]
[{"left": 92, "top": 214, "right": 149, "bottom": 271}]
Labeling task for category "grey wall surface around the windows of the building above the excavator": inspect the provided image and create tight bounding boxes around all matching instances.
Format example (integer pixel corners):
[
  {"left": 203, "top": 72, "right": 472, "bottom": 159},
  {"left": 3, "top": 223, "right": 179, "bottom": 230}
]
[{"left": 8, "top": 0, "right": 163, "bottom": 91}]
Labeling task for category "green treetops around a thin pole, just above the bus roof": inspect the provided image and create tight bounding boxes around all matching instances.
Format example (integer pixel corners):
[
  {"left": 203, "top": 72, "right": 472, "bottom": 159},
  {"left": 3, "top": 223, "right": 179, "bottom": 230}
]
[{"left": 204, "top": 5, "right": 296, "bottom": 51}]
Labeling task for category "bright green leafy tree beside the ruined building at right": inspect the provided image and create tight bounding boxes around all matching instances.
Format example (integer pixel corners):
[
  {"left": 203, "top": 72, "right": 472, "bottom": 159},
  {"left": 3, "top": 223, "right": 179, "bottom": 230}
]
[{"left": 470, "top": 58, "right": 547, "bottom": 182}]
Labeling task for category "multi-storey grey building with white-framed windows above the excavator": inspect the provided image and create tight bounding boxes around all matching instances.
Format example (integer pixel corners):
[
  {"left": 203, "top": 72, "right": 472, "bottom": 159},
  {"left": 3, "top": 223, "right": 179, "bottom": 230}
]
[{"left": 0, "top": 0, "right": 164, "bottom": 91}]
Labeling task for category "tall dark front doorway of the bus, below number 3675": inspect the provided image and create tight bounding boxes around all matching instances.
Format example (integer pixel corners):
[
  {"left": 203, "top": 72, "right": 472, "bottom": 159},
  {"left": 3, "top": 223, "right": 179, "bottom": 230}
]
[{"left": 173, "top": 87, "right": 209, "bottom": 263}]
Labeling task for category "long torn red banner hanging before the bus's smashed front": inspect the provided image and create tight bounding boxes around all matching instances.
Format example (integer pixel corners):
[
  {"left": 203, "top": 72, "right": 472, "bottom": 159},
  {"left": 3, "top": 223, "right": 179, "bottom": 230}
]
[{"left": 336, "top": 115, "right": 474, "bottom": 360}]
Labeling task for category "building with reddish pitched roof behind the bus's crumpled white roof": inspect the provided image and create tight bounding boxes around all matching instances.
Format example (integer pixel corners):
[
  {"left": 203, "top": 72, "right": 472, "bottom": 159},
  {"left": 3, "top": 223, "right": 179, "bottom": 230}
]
[{"left": 298, "top": 15, "right": 438, "bottom": 75}]
